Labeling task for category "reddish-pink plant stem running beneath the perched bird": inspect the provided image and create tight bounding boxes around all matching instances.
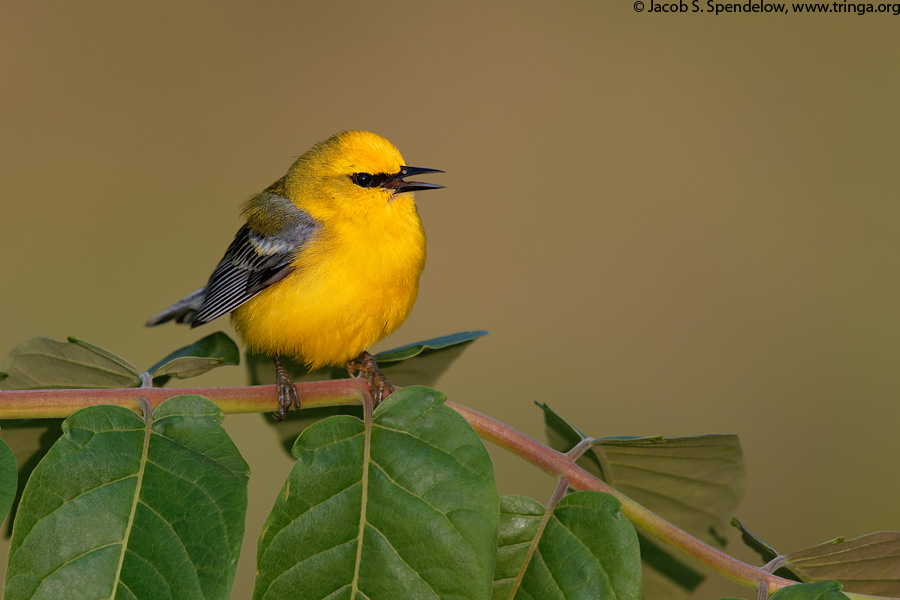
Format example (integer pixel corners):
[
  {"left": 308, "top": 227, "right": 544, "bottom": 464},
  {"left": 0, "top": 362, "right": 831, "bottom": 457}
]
[{"left": 0, "top": 378, "right": 892, "bottom": 600}]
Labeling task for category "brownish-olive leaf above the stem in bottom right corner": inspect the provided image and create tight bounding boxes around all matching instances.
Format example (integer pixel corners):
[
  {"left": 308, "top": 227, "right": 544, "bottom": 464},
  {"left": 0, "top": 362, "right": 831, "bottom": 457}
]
[{"left": 785, "top": 531, "right": 900, "bottom": 598}]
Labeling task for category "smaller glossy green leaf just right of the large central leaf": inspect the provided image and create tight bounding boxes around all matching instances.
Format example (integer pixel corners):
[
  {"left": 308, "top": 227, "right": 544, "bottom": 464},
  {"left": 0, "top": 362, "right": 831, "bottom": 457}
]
[{"left": 492, "top": 492, "right": 641, "bottom": 600}]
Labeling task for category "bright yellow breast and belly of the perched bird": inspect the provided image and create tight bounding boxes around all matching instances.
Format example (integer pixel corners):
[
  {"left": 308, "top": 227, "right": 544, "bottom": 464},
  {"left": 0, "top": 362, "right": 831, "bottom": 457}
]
[{"left": 232, "top": 204, "right": 425, "bottom": 368}]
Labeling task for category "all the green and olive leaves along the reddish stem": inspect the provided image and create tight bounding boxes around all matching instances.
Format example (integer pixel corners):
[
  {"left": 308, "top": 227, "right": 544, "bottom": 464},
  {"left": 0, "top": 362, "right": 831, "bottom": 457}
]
[{"left": 0, "top": 331, "right": 900, "bottom": 600}]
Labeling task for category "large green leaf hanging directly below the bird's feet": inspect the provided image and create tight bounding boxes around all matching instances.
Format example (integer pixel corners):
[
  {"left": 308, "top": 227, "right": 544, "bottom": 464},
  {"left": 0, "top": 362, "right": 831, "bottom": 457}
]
[{"left": 253, "top": 387, "right": 499, "bottom": 600}]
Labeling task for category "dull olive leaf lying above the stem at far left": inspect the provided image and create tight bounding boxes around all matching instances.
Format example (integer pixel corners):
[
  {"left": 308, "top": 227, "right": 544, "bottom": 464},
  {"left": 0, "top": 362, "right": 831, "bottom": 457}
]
[{"left": 0, "top": 337, "right": 141, "bottom": 390}]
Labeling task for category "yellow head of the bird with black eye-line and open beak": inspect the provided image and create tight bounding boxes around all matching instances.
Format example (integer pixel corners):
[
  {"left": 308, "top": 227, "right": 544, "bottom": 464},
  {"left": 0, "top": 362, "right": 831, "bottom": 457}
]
[{"left": 285, "top": 130, "right": 444, "bottom": 217}]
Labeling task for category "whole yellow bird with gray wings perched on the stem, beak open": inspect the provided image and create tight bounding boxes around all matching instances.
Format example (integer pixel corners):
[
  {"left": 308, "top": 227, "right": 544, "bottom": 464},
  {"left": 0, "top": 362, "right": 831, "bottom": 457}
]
[{"left": 146, "top": 131, "right": 444, "bottom": 420}]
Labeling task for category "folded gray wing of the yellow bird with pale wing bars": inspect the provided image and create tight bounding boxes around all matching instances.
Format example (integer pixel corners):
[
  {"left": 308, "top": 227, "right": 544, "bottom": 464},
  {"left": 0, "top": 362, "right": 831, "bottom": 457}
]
[{"left": 190, "top": 192, "right": 319, "bottom": 327}]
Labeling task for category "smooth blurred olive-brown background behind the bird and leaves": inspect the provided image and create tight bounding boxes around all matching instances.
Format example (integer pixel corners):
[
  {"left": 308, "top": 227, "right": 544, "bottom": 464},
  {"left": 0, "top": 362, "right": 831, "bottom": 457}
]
[{"left": 0, "top": 0, "right": 900, "bottom": 598}]
